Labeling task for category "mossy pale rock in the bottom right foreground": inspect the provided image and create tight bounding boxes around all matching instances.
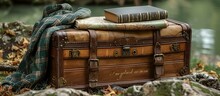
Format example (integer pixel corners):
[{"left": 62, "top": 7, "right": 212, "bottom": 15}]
[{"left": 124, "top": 79, "right": 220, "bottom": 96}]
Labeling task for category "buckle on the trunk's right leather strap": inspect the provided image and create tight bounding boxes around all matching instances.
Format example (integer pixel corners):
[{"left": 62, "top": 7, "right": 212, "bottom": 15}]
[{"left": 154, "top": 54, "right": 164, "bottom": 66}]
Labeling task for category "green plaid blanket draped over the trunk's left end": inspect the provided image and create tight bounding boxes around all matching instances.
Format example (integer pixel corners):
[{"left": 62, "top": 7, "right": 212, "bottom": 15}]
[{"left": 2, "top": 3, "right": 91, "bottom": 92}]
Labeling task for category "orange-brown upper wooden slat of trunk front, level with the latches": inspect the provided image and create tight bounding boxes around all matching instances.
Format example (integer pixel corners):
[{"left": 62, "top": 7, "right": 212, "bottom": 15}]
[{"left": 63, "top": 43, "right": 186, "bottom": 58}]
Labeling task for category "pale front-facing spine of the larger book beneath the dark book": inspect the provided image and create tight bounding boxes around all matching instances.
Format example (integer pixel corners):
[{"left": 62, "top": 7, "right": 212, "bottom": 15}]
[{"left": 75, "top": 20, "right": 168, "bottom": 31}]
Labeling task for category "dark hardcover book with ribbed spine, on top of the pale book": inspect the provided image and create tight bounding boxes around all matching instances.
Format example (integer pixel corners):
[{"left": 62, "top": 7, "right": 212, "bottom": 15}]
[{"left": 104, "top": 5, "right": 168, "bottom": 23}]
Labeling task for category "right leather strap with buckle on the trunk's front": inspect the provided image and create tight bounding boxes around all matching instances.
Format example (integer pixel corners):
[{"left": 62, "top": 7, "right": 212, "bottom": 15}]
[{"left": 153, "top": 30, "right": 164, "bottom": 79}]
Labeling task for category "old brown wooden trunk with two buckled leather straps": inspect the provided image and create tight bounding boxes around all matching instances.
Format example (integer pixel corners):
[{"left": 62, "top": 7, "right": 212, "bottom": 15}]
[{"left": 49, "top": 20, "right": 191, "bottom": 88}]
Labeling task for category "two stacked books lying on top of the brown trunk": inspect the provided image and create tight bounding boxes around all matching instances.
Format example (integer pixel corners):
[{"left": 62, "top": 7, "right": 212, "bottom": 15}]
[{"left": 75, "top": 5, "right": 168, "bottom": 31}]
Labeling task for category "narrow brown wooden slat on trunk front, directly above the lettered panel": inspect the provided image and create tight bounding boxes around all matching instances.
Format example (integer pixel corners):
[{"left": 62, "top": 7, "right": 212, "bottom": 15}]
[{"left": 64, "top": 52, "right": 184, "bottom": 69}]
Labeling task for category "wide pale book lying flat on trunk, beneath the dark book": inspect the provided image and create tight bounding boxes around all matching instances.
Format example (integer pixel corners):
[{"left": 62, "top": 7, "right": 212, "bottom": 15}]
[{"left": 75, "top": 16, "right": 168, "bottom": 30}]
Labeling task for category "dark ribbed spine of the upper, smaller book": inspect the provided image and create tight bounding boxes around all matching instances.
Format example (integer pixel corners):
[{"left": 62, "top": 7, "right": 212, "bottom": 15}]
[{"left": 118, "top": 11, "right": 168, "bottom": 23}]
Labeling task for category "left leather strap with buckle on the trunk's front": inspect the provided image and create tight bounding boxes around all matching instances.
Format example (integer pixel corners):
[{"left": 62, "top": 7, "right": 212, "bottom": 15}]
[{"left": 88, "top": 30, "right": 99, "bottom": 88}]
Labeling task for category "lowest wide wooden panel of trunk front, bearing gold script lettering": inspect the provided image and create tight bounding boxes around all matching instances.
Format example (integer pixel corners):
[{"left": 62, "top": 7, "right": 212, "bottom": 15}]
[{"left": 64, "top": 60, "right": 184, "bottom": 86}]
